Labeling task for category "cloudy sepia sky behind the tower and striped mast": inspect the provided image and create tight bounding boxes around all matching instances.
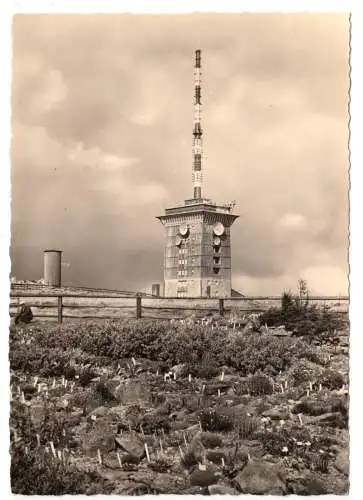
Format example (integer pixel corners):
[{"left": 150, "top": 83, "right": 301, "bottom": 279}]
[{"left": 11, "top": 14, "right": 349, "bottom": 295}]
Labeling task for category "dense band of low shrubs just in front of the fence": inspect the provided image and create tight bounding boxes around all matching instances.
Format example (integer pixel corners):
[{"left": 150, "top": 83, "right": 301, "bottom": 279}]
[{"left": 9, "top": 320, "right": 330, "bottom": 376}]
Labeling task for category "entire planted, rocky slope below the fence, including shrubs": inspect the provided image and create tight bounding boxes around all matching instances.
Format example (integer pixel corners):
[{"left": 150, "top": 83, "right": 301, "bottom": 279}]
[{"left": 10, "top": 300, "right": 349, "bottom": 495}]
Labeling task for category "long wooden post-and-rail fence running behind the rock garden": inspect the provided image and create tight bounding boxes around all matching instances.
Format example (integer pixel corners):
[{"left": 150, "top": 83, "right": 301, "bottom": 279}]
[{"left": 10, "top": 290, "right": 349, "bottom": 323}]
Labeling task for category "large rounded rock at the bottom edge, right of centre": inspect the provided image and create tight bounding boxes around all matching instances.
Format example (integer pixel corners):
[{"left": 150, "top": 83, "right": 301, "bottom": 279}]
[{"left": 235, "top": 461, "right": 287, "bottom": 495}]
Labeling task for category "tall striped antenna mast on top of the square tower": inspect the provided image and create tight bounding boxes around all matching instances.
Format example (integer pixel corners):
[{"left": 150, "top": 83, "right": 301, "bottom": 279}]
[{"left": 193, "top": 50, "right": 203, "bottom": 199}]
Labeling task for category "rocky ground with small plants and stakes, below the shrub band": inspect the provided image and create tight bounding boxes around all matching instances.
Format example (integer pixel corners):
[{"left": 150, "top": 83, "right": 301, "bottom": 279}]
[{"left": 10, "top": 318, "right": 349, "bottom": 495}]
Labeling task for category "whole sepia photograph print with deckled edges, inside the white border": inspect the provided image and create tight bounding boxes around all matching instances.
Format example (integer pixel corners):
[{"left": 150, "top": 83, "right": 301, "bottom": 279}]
[{"left": 9, "top": 12, "right": 351, "bottom": 496}]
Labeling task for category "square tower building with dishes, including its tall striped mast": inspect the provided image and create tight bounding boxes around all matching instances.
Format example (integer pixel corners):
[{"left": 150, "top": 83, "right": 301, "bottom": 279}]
[{"left": 157, "top": 50, "right": 238, "bottom": 298}]
